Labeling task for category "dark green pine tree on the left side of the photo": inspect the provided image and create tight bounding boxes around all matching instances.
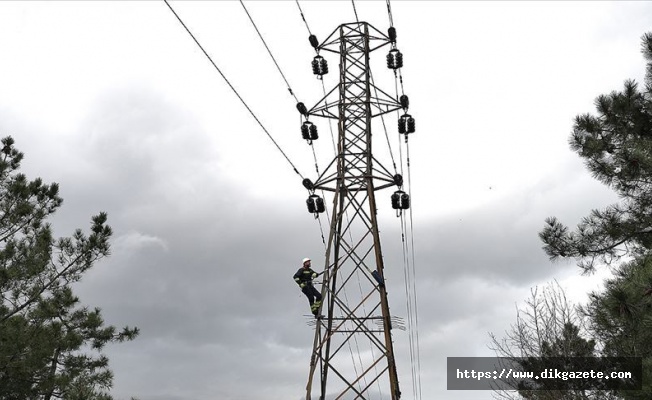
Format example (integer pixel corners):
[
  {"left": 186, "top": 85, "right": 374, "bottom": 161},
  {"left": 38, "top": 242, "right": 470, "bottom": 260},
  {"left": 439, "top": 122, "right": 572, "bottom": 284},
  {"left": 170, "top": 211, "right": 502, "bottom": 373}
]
[{"left": 0, "top": 137, "right": 138, "bottom": 400}]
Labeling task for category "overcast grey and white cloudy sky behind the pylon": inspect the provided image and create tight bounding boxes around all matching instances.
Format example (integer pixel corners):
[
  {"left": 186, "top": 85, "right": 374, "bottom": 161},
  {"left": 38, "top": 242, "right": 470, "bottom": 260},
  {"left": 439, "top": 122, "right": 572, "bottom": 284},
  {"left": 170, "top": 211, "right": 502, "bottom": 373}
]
[{"left": 0, "top": 1, "right": 652, "bottom": 400}]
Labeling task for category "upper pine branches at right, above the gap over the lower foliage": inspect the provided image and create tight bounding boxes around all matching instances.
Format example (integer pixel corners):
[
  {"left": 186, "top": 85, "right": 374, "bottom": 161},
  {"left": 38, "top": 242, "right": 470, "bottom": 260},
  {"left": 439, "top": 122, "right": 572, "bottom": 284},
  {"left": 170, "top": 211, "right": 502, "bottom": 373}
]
[{"left": 539, "top": 33, "right": 652, "bottom": 272}]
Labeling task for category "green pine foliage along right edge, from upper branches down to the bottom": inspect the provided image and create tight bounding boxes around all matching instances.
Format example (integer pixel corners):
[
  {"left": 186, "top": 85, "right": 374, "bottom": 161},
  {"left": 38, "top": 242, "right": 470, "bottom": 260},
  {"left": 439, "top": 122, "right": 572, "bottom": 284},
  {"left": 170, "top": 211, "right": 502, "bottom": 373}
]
[{"left": 539, "top": 33, "right": 652, "bottom": 399}]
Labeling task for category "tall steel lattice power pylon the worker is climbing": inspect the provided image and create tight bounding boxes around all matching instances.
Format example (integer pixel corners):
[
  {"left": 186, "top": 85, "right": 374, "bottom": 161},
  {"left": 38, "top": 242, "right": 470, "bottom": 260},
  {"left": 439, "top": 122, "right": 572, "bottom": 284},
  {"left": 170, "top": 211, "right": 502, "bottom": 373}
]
[{"left": 304, "top": 22, "right": 402, "bottom": 400}]
